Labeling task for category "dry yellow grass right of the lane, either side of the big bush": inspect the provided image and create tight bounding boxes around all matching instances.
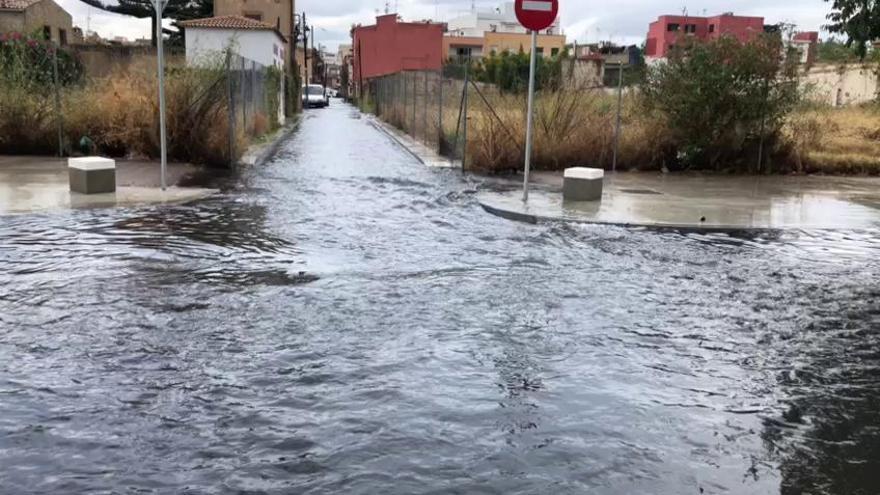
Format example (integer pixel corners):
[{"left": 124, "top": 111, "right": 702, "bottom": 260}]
[{"left": 426, "top": 88, "right": 880, "bottom": 175}]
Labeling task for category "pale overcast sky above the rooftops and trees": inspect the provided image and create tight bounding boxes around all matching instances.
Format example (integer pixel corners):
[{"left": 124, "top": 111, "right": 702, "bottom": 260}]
[{"left": 56, "top": 0, "right": 829, "bottom": 49}]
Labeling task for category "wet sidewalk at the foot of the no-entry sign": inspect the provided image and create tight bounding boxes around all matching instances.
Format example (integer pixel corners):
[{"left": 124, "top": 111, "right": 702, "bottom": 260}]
[{"left": 479, "top": 172, "right": 880, "bottom": 230}]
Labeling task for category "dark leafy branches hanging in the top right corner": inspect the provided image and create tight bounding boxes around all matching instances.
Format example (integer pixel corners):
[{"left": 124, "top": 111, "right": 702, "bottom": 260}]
[{"left": 825, "top": 0, "right": 880, "bottom": 59}]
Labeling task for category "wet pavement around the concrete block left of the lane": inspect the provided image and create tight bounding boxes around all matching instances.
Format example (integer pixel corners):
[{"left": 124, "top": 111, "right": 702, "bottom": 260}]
[{"left": 0, "top": 156, "right": 217, "bottom": 214}]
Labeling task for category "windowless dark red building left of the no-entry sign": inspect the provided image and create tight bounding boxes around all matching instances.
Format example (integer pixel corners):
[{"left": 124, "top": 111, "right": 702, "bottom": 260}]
[{"left": 351, "top": 14, "right": 446, "bottom": 83}]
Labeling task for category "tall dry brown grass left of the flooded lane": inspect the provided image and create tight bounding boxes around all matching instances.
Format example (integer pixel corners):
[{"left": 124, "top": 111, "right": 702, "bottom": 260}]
[{"left": 0, "top": 66, "right": 248, "bottom": 165}]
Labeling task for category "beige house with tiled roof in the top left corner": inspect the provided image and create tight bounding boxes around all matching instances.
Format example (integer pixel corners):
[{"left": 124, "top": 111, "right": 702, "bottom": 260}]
[{"left": 0, "top": 0, "right": 73, "bottom": 45}]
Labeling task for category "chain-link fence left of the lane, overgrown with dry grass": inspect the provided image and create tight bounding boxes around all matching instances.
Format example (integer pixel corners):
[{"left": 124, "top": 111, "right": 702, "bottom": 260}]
[{"left": 0, "top": 34, "right": 285, "bottom": 167}]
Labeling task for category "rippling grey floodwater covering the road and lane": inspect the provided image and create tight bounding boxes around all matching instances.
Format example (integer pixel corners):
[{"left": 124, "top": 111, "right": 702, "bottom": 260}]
[{"left": 0, "top": 104, "right": 880, "bottom": 494}]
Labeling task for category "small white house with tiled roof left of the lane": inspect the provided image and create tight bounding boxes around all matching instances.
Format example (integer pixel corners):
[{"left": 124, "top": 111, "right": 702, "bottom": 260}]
[{"left": 180, "top": 15, "right": 285, "bottom": 122}]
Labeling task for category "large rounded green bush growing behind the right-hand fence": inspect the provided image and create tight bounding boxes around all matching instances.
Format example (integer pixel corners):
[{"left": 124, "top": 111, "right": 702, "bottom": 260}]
[{"left": 642, "top": 34, "right": 800, "bottom": 170}]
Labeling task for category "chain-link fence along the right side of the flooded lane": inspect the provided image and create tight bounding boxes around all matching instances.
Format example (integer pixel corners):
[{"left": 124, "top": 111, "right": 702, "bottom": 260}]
[{"left": 361, "top": 60, "right": 637, "bottom": 171}]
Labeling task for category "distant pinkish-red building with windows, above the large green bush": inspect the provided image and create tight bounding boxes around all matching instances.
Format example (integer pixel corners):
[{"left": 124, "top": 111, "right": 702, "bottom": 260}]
[{"left": 645, "top": 13, "right": 764, "bottom": 58}]
